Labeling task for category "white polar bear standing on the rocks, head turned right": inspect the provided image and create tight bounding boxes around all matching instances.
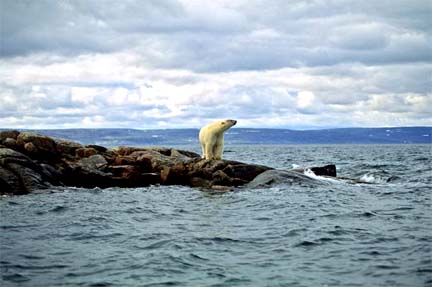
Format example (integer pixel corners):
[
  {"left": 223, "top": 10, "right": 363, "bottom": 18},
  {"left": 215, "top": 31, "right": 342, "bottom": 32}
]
[{"left": 199, "top": 120, "right": 237, "bottom": 160}]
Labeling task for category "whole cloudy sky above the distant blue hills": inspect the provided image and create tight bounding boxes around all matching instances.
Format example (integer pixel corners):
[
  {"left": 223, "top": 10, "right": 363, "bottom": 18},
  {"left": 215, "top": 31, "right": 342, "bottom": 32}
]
[{"left": 0, "top": 0, "right": 432, "bottom": 129}]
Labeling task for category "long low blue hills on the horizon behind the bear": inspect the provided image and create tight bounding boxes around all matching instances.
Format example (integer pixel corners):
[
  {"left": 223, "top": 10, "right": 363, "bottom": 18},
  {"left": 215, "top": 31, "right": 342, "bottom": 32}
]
[{"left": 2, "top": 127, "right": 432, "bottom": 146}]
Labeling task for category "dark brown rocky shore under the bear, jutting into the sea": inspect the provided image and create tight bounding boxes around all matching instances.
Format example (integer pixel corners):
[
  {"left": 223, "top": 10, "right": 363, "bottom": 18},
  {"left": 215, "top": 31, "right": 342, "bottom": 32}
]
[{"left": 0, "top": 130, "right": 336, "bottom": 195}]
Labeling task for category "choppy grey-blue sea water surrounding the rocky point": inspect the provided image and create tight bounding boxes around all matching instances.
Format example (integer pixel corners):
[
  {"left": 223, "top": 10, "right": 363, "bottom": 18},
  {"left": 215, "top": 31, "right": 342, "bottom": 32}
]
[{"left": 0, "top": 145, "right": 432, "bottom": 287}]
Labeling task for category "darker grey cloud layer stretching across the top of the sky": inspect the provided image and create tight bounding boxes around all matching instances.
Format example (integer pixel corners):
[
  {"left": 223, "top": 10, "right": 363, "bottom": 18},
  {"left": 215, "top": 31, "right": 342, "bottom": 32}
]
[{"left": 1, "top": 0, "right": 432, "bottom": 72}]
